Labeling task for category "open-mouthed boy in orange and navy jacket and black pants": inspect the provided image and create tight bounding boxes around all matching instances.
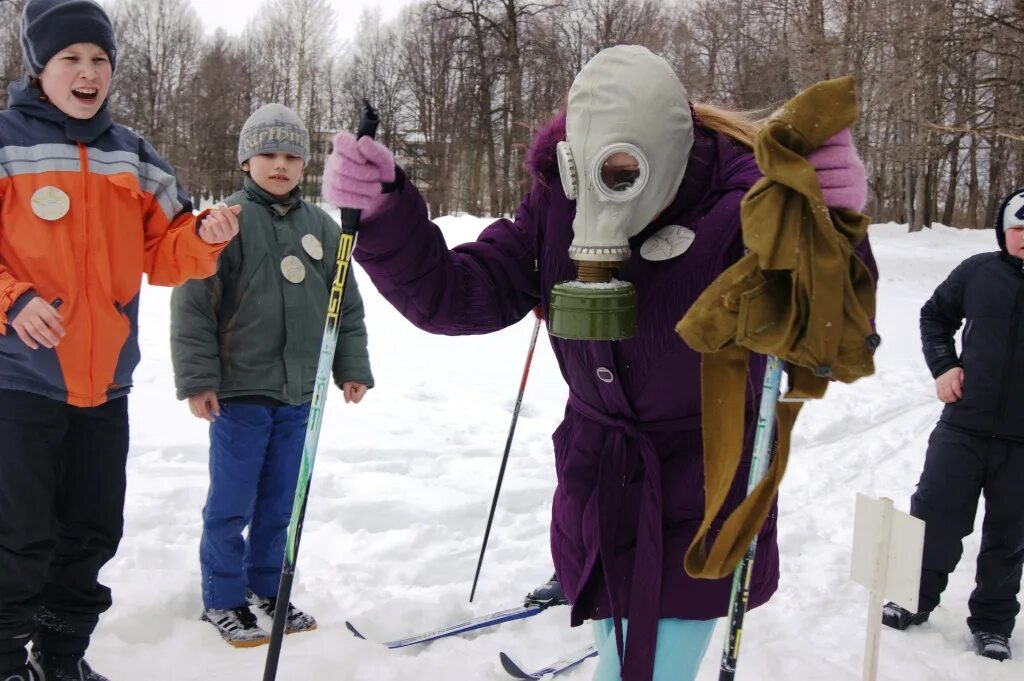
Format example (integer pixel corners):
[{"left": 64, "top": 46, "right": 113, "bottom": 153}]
[{"left": 0, "top": 0, "right": 239, "bottom": 681}]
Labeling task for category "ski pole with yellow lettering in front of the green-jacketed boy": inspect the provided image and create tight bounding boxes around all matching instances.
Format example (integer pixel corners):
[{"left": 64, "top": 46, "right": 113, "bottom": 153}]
[{"left": 263, "top": 100, "right": 380, "bottom": 681}]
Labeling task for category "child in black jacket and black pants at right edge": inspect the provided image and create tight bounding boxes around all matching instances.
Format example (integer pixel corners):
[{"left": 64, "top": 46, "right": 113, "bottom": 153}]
[{"left": 883, "top": 189, "right": 1024, "bottom": 661}]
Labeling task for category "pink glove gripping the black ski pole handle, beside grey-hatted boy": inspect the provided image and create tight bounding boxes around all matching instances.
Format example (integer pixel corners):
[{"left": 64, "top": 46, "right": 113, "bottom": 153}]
[{"left": 324, "top": 132, "right": 394, "bottom": 211}]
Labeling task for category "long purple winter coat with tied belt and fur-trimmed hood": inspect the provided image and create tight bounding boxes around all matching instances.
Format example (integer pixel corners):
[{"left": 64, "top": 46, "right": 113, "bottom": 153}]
[{"left": 354, "top": 119, "right": 873, "bottom": 681}]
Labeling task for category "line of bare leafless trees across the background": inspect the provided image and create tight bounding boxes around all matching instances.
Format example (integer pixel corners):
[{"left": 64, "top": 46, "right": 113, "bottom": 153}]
[{"left": 0, "top": 0, "right": 1024, "bottom": 224}]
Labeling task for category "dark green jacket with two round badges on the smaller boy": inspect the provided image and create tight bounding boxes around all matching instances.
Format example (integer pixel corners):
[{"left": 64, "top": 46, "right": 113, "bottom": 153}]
[{"left": 171, "top": 175, "right": 374, "bottom": 405}]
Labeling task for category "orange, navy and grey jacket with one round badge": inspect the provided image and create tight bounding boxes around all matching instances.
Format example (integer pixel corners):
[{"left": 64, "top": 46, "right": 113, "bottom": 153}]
[{"left": 0, "top": 80, "right": 223, "bottom": 407}]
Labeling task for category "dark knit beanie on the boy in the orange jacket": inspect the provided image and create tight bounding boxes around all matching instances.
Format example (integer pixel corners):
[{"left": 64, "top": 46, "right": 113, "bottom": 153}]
[{"left": 22, "top": 0, "right": 118, "bottom": 76}]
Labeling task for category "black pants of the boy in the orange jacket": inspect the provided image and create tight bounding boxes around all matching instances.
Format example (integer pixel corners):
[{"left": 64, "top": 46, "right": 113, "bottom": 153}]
[{"left": 0, "top": 390, "right": 128, "bottom": 677}]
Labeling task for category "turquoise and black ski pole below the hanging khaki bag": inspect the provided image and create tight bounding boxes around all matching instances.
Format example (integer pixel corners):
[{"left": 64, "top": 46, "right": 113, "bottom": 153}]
[{"left": 718, "top": 355, "right": 782, "bottom": 681}]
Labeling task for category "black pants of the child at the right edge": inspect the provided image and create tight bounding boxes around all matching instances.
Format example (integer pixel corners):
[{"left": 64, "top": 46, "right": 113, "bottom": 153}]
[{"left": 910, "top": 423, "right": 1024, "bottom": 636}]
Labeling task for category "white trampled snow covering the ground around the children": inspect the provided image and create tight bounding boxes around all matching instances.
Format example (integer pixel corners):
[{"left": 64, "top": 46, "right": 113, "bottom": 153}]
[{"left": 81, "top": 217, "right": 1024, "bottom": 681}]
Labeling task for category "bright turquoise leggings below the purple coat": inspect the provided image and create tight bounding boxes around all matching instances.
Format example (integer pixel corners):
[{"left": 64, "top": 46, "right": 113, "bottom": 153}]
[{"left": 594, "top": 619, "right": 718, "bottom": 681}]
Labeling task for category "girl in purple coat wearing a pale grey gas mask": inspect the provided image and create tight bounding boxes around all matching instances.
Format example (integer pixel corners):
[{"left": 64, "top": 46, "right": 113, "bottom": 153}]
[{"left": 324, "top": 46, "right": 873, "bottom": 681}]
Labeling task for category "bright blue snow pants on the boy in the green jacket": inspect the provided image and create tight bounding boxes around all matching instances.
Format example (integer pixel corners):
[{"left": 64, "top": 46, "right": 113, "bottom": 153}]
[{"left": 199, "top": 402, "right": 309, "bottom": 609}]
